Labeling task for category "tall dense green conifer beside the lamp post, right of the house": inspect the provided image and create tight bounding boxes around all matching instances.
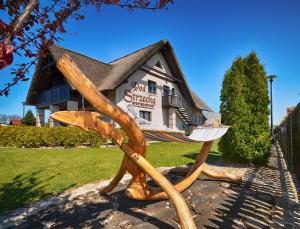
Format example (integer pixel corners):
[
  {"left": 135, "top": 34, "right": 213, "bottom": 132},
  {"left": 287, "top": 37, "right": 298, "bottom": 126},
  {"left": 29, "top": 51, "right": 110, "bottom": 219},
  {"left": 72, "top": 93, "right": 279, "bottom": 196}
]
[{"left": 220, "top": 52, "right": 270, "bottom": 164}]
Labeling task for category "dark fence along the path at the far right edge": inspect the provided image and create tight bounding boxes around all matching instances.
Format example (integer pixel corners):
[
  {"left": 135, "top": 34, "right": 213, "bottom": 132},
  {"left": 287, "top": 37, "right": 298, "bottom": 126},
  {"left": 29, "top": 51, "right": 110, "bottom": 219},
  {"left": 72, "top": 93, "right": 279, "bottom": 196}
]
[{"left": 275, "top": 103, "right": 300, "bottom": 179}]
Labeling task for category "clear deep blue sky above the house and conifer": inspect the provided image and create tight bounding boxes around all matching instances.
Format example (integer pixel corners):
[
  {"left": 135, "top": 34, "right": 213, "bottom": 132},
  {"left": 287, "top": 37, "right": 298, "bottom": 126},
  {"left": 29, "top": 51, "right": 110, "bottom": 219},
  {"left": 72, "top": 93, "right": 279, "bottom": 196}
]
[{"left": 0, "top": 0, "right": 300, "bottom": 123}]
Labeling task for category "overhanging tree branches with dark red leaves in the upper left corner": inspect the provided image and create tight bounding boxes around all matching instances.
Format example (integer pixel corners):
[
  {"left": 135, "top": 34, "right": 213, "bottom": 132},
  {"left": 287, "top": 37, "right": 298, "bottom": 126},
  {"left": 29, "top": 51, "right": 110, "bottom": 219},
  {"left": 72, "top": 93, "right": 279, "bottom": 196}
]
[{"left": 0, "top": 0, "right": 172, "bottom": 96}]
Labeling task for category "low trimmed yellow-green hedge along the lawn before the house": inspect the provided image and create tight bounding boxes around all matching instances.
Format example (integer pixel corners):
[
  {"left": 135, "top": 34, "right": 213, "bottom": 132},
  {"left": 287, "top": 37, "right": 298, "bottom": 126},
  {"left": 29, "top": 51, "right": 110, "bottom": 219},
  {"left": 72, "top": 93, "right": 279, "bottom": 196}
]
[{"left": 0, "top": 126, "right": 124, "bottom": 148}]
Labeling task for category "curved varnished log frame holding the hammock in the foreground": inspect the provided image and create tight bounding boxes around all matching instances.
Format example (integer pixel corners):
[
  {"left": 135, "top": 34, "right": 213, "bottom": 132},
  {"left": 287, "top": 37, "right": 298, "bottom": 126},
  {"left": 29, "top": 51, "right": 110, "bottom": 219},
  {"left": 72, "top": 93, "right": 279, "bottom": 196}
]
[{"left": 51, "top": 54, "right": 242, "bottom": 228}]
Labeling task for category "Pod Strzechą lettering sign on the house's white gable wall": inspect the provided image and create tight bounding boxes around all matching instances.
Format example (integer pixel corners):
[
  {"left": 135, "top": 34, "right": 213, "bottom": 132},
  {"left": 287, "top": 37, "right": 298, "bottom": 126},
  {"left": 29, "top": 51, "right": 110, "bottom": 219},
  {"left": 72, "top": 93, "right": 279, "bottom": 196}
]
[{"left": 123, "top": 82, "right": 155, "bottom": 109}]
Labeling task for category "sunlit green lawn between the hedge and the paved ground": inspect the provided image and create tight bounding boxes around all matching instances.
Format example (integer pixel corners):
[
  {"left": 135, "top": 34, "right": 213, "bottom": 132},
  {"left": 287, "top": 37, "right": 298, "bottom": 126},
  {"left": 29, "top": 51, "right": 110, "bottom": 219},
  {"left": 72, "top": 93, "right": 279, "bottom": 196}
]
[{"left": 0, "top": 143, "right": 221, "bottom": 214}]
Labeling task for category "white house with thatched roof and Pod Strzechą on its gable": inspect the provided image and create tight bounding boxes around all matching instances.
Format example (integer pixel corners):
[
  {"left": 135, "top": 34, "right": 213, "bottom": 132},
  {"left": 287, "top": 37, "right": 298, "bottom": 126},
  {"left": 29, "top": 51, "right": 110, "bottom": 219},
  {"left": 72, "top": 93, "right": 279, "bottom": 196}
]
[{"left": 26, "top": 40, "right": 211, "bottom": 131}]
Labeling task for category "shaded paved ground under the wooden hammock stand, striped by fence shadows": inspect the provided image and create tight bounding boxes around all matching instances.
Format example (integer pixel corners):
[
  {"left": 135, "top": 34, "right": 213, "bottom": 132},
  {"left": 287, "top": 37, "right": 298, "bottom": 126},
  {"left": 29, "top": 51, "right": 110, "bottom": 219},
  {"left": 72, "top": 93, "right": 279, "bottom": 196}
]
[{"left": 1, "top": 142, "right": 300, "bottom": 229}]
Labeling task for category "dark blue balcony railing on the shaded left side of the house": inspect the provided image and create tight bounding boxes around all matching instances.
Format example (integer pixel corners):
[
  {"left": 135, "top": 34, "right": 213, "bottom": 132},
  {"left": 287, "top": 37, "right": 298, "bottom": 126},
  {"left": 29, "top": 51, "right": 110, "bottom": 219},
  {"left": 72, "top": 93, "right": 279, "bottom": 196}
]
[{"left": 36, "top": 84, "right": 72, "bottom": 107}]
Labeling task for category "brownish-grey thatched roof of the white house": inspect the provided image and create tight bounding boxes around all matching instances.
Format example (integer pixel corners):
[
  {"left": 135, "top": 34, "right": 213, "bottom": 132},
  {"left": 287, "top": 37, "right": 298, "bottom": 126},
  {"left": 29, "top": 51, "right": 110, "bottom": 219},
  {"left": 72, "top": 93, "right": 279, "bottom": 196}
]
[{"left": 27, "top": 40, "right": 211, "bottom": 111}]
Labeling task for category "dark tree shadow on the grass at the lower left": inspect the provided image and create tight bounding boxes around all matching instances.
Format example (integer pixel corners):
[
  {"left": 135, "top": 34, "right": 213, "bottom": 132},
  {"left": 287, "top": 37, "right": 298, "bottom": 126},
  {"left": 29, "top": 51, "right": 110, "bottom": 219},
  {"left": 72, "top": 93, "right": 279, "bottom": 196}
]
[{"left": 0, "top": 170, "right": 74, "bottom": 214}]
